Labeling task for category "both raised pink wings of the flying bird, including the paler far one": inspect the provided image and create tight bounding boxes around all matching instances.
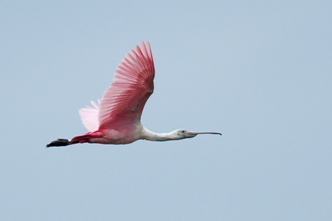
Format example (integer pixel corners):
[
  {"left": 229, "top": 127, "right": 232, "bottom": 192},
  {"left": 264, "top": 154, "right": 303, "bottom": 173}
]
[{"left": 80, "top": 42, "right": 155, "bottom": 131}]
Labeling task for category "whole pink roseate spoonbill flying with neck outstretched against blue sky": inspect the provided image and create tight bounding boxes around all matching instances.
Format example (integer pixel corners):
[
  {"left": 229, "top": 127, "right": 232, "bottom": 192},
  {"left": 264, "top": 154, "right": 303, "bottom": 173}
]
[{"left": 47, "top": 42, "right": 221, "bottom": 147}]
